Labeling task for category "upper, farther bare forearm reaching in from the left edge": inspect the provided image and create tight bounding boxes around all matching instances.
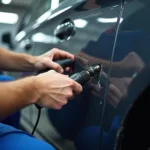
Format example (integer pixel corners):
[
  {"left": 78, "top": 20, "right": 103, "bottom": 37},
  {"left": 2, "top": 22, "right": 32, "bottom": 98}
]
[{"left": 0, "top": 48, "right": 35, "bottom": 71}]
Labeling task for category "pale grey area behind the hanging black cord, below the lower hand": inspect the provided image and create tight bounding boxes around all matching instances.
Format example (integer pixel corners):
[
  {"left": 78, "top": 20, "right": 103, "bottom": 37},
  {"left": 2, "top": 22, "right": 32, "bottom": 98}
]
[{"left": 21, "top": 105, "right": 76, "bottom": 150}]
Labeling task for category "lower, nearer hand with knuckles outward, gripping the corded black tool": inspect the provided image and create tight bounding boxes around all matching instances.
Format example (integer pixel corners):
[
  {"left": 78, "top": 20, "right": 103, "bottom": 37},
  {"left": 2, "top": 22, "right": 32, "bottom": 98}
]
[{"left": 35, "top": 70, "right": 82, "bottom": 109}]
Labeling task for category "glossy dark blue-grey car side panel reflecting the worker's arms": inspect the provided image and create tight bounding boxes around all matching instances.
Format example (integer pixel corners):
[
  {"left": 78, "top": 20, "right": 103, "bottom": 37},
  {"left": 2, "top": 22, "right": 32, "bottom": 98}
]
[{"left": 8, "top": 0, "right": 150, "bottom": 150}]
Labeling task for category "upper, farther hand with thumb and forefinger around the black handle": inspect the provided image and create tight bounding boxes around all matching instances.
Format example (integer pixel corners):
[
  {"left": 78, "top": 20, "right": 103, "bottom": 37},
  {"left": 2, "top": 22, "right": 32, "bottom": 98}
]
[{"left": 34, "top": 48, "right": 74, "bottom": 73}]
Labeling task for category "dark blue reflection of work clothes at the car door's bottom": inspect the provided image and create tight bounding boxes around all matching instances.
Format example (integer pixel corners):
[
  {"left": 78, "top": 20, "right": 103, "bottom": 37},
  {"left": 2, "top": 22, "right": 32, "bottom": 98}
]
[{"left": 75, "top": 116, "right": 120, "bottom": 150}]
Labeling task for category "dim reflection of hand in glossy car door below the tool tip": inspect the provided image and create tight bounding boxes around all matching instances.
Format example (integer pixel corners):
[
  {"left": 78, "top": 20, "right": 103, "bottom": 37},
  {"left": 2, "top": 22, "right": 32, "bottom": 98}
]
[{"left": 90, "top": 72, "right": 132, "bottom": 108}]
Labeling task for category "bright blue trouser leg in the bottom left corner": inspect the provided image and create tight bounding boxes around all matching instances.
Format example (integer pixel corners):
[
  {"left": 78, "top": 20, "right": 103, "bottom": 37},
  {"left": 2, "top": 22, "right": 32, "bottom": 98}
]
[{"left": 0, "top": 123, "right": 54, "bottom": 150}]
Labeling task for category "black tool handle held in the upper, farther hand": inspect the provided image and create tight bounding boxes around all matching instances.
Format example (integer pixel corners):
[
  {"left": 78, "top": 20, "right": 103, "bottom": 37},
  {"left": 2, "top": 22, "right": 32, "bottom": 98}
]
[{"left": 38, "top": 59, "right": 73, "bottom": 74}]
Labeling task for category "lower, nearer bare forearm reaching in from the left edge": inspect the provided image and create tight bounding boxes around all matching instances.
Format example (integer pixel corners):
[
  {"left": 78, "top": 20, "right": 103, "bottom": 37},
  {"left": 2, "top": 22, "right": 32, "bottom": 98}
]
[{"left": 0, "top": 77, "right": 38, "bottom": 118}]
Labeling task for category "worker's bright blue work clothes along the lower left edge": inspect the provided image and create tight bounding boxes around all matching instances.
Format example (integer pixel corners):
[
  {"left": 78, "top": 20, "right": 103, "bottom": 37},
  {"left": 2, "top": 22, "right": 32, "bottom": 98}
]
[{"left": 0, "top": 75, "right": 54, "bottom": 150}]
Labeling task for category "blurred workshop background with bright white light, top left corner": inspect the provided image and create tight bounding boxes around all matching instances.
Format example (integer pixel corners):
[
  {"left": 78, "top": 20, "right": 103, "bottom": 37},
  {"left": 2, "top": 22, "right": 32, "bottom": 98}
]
[{"left": 0, "top": 0, "right": 33, "bottom": 46}]
